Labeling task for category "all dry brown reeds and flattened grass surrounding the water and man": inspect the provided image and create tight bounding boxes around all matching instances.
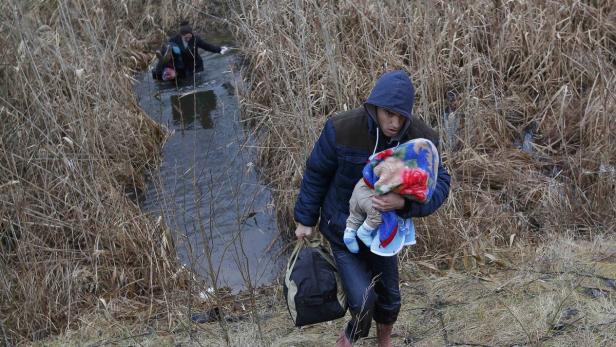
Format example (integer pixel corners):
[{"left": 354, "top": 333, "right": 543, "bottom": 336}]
[{"left": 0, "top": 0, "right": 616, "bottom": 346}]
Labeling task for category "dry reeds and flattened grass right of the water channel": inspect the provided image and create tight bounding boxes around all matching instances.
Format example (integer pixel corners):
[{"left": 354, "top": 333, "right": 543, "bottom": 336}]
[{"left": 226, "top": 0, "right": 616, "bottom": 346}]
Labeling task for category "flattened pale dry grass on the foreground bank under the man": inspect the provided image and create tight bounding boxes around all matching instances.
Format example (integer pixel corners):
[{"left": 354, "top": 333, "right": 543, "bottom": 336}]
[{"left": 35, "top": 236, "right": 616, "bottom": 347}]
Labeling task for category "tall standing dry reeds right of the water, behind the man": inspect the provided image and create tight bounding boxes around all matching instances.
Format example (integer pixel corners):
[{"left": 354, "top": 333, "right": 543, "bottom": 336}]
[{"left": 235, "top": 0, "right": 616, "bottom": 256}]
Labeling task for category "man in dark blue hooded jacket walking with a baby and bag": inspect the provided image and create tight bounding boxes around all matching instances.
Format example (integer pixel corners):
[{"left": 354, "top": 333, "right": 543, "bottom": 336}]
[{"left": 294, "top": 70, "right": 450, "bottom": 346}]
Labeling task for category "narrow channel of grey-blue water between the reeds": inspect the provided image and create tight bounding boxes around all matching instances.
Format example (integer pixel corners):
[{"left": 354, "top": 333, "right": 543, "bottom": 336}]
[{"left": 135, "top": 37, "right": 282, "bottom": 291}]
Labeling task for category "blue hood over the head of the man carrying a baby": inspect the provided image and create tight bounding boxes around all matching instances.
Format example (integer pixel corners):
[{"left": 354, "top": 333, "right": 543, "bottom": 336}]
[{"left": 364, "top": 70, "right": 415, "bottom": 141}]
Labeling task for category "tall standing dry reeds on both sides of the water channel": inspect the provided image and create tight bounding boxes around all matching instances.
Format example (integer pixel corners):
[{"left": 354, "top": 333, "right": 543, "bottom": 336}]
[{"left": 0, "top": 0, "right": 616, "bottom": 341}]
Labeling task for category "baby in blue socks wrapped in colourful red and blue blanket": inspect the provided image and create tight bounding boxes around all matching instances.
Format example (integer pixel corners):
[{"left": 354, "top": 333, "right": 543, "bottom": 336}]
[{"left": 344, "top": 138, "right": 439, "bottom": 256}]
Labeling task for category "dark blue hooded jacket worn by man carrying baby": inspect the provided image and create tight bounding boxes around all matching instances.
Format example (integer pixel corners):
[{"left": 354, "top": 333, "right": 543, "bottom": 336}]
[{"left": 294, "top": 70, "right": 450, "bottom": 247}]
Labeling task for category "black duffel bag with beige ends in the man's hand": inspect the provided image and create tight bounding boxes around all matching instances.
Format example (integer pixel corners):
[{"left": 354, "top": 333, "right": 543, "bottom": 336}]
[{"left": 284, "top": 240, "right": 347, "bottom": 327}]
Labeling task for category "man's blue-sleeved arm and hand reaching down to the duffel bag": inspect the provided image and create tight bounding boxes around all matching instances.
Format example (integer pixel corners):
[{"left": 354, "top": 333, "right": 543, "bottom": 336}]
[{"left": 294, "top": 120, "right": 338, "bottom": 239}]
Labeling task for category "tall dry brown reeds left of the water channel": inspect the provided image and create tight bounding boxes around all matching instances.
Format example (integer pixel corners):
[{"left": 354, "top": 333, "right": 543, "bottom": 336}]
[{"left": 0, "top": 0, "right": 230, "bottom": 342}]
